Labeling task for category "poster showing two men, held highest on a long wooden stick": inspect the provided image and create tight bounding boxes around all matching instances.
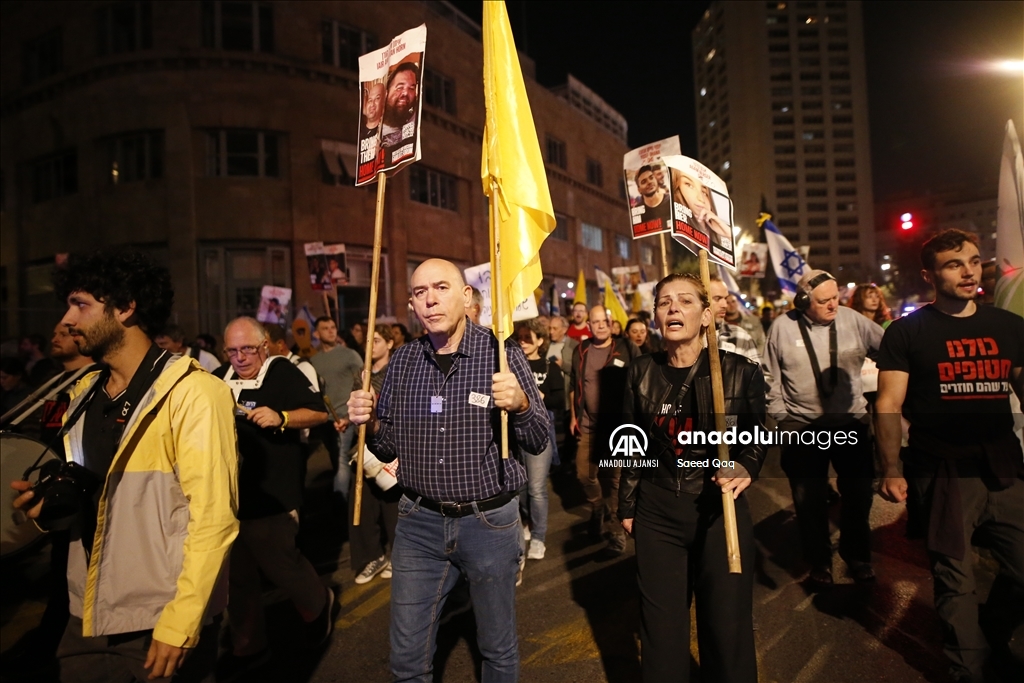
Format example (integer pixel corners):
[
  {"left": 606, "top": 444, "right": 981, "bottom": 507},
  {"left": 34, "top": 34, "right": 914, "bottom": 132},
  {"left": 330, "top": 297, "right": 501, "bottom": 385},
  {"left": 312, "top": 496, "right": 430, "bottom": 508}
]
[{"left": 355, "top": 24, "right": 427, "bottom": 185}]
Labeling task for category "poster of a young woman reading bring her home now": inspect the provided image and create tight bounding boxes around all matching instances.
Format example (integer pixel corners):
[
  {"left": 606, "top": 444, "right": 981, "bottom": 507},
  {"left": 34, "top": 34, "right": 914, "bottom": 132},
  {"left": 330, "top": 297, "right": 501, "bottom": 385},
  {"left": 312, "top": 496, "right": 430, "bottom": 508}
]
[{"left": 664, "top": 156, "right": 736, "bottom": 270}]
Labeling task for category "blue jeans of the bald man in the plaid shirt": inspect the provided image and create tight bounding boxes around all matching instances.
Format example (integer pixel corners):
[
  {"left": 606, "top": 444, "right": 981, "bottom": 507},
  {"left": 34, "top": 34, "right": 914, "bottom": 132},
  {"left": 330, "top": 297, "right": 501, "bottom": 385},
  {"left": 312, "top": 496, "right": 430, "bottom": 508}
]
[{"left": 391, "top": 496, "right": 522, "bottom": 683}]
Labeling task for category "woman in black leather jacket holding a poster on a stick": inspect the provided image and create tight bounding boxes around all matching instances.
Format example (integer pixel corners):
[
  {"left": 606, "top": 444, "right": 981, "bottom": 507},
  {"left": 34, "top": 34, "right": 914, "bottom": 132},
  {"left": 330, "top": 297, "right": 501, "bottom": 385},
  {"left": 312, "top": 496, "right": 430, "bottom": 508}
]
[{"left": 618, "top": 274, "right": 767, "bottom": 683}]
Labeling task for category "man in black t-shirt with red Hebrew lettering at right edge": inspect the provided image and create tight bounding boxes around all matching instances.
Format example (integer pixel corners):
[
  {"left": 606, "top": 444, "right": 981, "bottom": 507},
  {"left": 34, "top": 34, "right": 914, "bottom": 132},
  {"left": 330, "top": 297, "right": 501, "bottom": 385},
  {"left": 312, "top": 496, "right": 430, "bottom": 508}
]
[{"left": 876, "top": 230, "right": 1024, "bottom": 681}]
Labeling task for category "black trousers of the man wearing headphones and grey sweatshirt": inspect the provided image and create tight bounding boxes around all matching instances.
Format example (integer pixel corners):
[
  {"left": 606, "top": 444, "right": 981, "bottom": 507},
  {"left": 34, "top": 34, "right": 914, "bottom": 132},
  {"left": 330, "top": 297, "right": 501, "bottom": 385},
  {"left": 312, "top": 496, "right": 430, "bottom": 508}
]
[{"left": 782, "top": 422, "right": 874, "bottom": 568}]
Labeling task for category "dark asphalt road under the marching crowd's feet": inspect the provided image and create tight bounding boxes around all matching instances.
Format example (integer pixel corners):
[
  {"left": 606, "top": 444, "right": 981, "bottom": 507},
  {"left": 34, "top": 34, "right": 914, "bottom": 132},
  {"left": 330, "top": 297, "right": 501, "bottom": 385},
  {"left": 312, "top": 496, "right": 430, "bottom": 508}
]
[{"left": 0, "top": 450, "right": 1024, "bottom": 683}]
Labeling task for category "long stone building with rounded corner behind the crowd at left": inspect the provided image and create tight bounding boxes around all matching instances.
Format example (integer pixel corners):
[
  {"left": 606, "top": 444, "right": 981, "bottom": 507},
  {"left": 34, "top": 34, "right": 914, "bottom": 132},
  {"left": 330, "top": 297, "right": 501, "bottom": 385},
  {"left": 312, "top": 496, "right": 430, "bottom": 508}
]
[{"left": 0, "top": 0, "right": 630, "bottom": 337}]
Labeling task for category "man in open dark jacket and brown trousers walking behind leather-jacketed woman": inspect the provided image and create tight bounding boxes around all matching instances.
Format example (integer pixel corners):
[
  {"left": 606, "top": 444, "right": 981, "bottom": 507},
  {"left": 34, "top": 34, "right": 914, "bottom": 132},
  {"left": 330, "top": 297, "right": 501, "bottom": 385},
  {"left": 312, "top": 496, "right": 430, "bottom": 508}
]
[{"left": 569, "top": 305, "right": 640, "bottom": 555}]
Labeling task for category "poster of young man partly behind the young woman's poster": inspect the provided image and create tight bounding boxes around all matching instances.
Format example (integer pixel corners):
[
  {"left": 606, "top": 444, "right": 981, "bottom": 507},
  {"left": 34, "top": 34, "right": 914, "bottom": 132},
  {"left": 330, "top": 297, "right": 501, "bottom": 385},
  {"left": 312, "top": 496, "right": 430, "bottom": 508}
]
[{"left": 623, "top": 135, "right": 680, "bottom": 240}]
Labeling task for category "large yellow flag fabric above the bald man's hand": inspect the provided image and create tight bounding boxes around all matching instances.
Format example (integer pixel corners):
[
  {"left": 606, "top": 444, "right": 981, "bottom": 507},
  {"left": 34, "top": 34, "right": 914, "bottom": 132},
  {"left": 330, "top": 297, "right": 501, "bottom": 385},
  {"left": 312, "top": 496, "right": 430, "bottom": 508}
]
[{"left": 480, "top": 2, "right": 555, "bottom": 338}]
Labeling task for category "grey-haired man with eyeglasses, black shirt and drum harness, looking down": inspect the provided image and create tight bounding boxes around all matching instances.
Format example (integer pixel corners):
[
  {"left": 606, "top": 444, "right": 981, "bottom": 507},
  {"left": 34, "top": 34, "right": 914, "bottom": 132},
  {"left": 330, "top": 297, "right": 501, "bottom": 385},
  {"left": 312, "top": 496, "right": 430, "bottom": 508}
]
[{"left": 215, "top": 317, "right": 334, "bottom": 680}]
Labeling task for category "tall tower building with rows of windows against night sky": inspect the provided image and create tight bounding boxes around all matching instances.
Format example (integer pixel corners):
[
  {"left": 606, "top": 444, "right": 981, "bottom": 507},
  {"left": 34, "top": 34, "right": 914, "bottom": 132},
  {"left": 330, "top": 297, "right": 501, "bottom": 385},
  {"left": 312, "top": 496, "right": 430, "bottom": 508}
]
[{"left": 693, "top": 0, "right": 874, "bottom": 283}]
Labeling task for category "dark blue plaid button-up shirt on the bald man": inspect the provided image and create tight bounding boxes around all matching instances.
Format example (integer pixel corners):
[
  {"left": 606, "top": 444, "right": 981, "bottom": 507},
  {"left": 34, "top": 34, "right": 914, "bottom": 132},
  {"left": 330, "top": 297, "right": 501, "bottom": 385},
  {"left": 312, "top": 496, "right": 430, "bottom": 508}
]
[{"left": 369, "top": 319, "right": 548, "bottom": 503}]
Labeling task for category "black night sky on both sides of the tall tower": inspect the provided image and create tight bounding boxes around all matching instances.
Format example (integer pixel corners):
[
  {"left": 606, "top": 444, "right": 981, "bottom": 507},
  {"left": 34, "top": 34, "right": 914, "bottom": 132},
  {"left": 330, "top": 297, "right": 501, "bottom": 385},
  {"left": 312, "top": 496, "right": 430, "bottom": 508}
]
[{"left": 454, "top": 0, "right": 1024, "bottom": 201}]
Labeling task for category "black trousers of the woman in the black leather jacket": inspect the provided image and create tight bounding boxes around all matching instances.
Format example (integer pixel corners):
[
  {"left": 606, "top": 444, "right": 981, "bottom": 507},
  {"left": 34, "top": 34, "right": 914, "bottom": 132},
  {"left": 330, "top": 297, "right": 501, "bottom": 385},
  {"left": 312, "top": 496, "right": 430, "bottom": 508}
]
[{"left": 633, "top": 481, "right": 758, "bottom": 683}]
